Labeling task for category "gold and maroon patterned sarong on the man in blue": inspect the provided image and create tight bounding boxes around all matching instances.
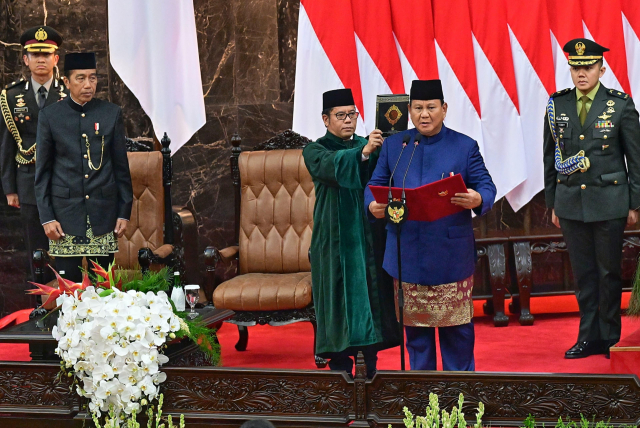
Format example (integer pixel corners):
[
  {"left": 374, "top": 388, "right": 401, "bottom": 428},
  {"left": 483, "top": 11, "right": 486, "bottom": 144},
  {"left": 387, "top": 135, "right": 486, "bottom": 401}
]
[{"left": 394, "top": 275, "right": 473, "bottom": 327}]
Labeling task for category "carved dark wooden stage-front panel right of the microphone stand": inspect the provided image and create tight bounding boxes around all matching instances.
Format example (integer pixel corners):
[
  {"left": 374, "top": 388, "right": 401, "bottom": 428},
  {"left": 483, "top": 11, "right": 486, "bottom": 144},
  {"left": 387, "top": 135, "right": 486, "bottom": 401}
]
[{"left": 367, "top": 372, "right": 640, "bottom": 427}]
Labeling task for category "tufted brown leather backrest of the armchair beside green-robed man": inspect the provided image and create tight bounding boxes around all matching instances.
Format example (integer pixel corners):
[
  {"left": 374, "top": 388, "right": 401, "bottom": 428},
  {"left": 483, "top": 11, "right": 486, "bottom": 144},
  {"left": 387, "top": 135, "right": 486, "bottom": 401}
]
[{"left": 238, "top": 149, "right": 315, "bottom": 274}]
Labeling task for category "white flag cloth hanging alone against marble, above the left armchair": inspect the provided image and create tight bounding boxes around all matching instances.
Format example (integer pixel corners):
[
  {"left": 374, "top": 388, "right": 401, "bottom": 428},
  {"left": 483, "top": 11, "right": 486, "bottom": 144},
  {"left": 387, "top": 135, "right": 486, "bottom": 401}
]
[{"left": 109, "top": 0, "right": 206, "bottom": 153}]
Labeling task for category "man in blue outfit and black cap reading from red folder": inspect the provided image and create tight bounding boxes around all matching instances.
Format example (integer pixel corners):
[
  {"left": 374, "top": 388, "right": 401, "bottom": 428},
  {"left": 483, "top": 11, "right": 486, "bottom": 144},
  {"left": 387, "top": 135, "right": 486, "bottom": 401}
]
[{"left": 365, "top": 80, "right": 496, "bottom": 371}]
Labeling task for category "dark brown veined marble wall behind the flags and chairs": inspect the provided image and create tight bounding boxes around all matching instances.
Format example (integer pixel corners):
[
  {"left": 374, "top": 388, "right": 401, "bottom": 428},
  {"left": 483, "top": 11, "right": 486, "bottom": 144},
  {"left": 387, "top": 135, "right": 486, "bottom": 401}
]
[{"left": 0, "top": 0, "right": 636, "bottom": 315}]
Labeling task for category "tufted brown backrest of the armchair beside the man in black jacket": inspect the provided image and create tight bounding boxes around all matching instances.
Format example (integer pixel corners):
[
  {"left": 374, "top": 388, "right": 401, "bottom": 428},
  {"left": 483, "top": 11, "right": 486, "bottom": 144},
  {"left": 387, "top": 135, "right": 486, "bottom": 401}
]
[{"left": 115, "top": 151, "right": 164, "bottom": 269}]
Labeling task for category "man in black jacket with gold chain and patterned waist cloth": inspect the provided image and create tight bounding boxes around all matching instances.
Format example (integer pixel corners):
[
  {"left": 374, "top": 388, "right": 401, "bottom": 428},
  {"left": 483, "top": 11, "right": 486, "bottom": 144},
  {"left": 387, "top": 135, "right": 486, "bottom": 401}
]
[{"left": 35, "top": 53, "right": 133, "bottom": 281}]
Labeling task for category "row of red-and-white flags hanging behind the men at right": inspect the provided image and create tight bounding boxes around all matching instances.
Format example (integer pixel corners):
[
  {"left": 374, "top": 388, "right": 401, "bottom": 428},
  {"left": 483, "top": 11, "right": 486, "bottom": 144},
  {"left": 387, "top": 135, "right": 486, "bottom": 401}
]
[{"left": 293, "top": 0, "right": 640, "bottom": 211}]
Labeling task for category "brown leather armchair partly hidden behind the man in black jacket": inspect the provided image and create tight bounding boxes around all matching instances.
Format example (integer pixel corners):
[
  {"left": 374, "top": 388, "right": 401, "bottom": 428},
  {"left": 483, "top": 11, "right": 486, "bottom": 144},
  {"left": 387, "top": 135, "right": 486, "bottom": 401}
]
[{"left": 34, "top": 133, "right": 198, "bottom": 282}]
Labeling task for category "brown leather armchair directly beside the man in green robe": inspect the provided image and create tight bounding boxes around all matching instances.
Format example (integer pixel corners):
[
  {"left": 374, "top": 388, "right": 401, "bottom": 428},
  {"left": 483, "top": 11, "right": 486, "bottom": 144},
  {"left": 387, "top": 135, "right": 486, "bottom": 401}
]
[{"left": 205, "top": 131, "right": 326, "bottom": 368}]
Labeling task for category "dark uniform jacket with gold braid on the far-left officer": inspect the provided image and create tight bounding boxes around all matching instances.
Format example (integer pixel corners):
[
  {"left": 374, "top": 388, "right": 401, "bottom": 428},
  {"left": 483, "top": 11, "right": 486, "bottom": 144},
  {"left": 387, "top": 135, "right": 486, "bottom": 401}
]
[{"left": 0, "top": 79, "right": 68, "bottom": 205}]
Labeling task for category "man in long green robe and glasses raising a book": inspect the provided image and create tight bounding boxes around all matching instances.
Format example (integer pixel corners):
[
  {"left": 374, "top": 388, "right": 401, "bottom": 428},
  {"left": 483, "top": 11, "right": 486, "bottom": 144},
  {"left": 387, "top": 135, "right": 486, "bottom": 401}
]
[{"left": 303, "top": 89, "right": 399, "bottom": 377}]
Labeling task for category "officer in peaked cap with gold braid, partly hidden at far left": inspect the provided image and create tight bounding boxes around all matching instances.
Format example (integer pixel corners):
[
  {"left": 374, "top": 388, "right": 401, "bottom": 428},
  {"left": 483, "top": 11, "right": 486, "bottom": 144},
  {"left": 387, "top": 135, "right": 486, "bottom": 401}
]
[{"left": 0, "top": 26, "right": 68, "bottom": 288}]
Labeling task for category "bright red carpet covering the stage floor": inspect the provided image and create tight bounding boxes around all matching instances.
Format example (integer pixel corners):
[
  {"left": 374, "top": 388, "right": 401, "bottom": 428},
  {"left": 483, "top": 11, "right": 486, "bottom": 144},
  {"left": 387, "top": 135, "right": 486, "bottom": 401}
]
[{"left": 0, "top": 293, "right": 640, "bottom": 373}]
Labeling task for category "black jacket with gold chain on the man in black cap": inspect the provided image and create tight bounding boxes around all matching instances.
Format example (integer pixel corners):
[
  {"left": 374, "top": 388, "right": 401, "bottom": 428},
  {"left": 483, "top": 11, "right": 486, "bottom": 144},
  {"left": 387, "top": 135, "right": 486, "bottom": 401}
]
[{"left": 35, "top": 97, "right": 133, "bottom": 236}]
